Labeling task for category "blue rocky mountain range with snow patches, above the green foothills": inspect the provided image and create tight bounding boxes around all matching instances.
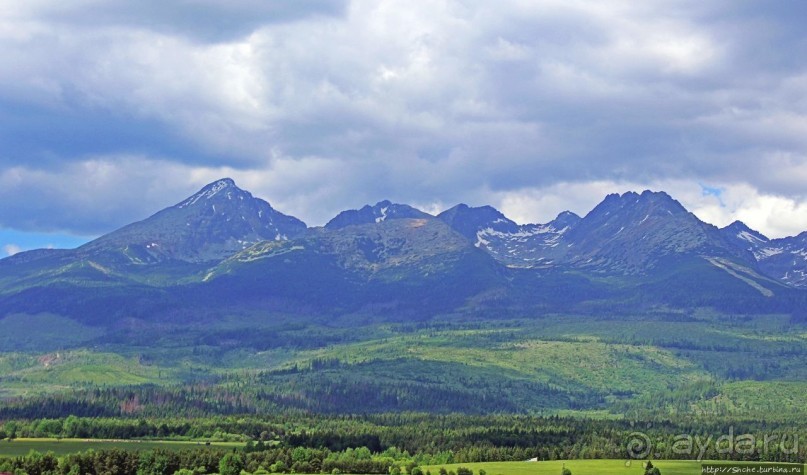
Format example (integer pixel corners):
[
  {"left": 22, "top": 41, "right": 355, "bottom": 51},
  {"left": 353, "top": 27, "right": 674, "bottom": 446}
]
[{"left": 0, "top": 178, "right": 807, "bottom": 326}]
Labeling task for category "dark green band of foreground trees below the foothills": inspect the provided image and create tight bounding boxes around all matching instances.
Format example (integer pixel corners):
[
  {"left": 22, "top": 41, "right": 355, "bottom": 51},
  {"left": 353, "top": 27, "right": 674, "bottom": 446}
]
[{"left": 0, "top": 413, "right": 807, "bottom": 466}]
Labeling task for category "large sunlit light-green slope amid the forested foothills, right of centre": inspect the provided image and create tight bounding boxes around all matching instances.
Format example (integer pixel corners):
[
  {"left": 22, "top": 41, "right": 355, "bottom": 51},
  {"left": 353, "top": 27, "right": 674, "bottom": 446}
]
[{"left": 280, "top": 331, "right": 709, "bottom": 391}]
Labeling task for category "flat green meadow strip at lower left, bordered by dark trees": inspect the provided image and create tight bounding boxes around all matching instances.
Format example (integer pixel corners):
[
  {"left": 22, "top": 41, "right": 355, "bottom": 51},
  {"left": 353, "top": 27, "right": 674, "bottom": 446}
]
[{"left": 0, "top": 439, "right": 244, "bottom": 457}]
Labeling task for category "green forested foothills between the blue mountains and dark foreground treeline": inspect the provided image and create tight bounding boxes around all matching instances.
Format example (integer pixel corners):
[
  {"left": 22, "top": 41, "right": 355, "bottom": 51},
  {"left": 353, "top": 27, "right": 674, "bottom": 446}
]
[{"left": 0, "top": 311, "right": 807, "bottom": 420}]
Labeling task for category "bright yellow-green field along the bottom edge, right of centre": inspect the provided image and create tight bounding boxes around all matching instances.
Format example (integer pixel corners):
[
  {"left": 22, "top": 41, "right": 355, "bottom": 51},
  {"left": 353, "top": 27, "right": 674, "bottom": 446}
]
[{"left": 423, "top": 460, "right": 804, "bottom": 475}]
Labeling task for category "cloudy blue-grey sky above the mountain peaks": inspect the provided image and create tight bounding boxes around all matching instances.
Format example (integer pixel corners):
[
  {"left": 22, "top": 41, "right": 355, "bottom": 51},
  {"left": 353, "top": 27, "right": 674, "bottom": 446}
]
[{"left": 0, "top": 0, "right": 807, "bottom": 256}]
